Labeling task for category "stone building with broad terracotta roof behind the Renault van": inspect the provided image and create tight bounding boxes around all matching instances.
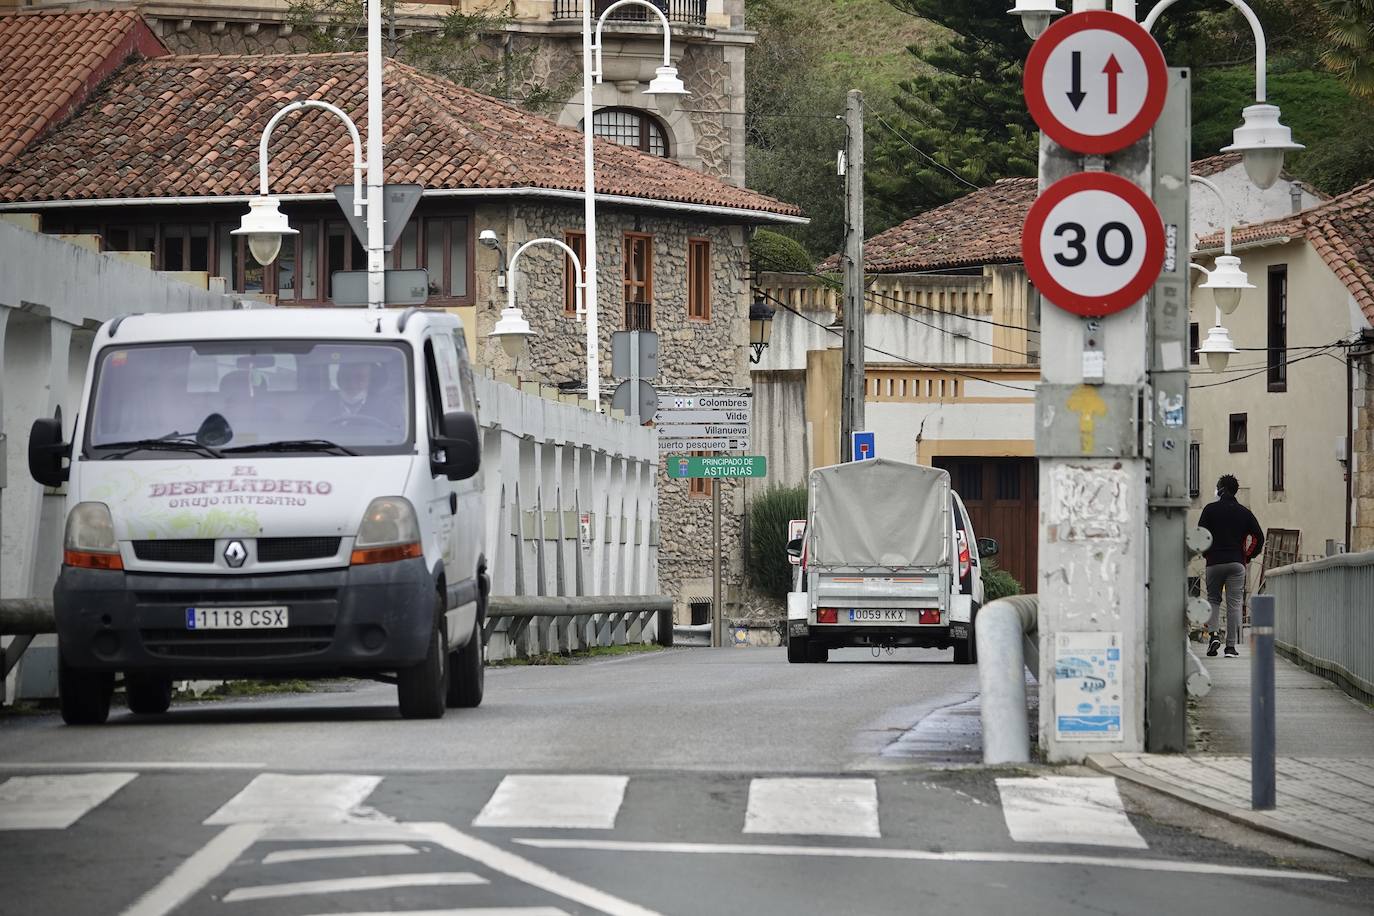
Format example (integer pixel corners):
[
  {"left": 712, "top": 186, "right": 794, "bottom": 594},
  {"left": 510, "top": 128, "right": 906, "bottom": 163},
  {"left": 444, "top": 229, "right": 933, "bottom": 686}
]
[{"left": 0, "top": 16, "right": 801, "bottom": 618}]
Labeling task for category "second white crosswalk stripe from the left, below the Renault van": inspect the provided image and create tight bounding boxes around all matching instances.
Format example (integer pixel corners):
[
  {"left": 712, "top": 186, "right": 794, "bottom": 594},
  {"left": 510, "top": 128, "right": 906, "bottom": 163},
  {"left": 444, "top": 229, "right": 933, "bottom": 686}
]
[{"left": 205, "top": 773, "right": 382, "bottom": 824}]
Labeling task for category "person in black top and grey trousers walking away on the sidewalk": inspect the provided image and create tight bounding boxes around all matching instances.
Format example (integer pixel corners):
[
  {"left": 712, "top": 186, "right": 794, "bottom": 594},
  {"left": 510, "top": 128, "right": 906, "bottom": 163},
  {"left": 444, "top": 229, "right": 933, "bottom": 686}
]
[{"left": 1198, "top": 474, "right": 1264, "bottom": 658}]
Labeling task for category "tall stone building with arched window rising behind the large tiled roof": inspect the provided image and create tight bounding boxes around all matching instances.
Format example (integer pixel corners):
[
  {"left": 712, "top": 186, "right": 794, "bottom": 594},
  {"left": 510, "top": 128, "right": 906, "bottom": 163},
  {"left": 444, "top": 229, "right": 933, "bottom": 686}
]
[{"left": 0, "top": 0, "right": 753, "bottom": 185}]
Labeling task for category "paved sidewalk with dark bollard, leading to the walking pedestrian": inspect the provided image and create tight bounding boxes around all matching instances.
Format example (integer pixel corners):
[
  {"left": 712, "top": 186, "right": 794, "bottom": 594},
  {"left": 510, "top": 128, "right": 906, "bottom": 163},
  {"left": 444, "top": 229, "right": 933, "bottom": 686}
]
[{"left": 1088, "top": 648, "right": 1374, "bottom": 862}]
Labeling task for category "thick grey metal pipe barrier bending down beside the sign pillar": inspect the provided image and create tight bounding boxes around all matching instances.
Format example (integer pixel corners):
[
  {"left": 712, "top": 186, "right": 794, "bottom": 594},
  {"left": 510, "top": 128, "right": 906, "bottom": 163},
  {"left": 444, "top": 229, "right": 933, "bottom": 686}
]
[{"left": 974, "top": 595, "right": 1040, "bottom": 764}]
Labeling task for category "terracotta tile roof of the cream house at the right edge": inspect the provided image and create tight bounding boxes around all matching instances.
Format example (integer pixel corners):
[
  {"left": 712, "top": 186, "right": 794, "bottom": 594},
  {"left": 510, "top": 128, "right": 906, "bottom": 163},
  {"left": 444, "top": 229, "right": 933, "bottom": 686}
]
[{"left": 1198, "top": 181, "right": 1374, "bottom": 323}]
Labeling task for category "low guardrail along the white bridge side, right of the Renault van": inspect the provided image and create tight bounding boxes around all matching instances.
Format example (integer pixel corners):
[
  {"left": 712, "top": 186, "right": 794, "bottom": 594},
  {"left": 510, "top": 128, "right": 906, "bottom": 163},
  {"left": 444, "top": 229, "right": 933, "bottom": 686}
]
[{"left": 482, "top": 595, "right": 673, "bottom": 658}]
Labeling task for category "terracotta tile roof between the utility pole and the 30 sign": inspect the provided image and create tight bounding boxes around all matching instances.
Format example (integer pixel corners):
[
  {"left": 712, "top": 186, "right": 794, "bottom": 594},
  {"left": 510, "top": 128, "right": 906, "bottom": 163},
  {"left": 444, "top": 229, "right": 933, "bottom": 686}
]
[{"left": 820, "top": 179, "right": 1036, "bottom": 273}]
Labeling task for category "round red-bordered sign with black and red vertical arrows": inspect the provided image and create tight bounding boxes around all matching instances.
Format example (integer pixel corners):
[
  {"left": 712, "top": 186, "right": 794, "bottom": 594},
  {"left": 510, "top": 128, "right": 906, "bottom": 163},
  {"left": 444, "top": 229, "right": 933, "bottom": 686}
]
[{"left": 1022, "top": 11, "right": 1169, "bottom": 154}]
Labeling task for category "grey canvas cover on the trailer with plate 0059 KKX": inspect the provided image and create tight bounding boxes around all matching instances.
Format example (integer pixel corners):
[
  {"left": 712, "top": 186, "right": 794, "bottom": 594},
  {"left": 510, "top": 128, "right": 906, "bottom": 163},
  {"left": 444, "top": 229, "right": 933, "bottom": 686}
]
[{"left": 808, "top": 459, "right": 949, "bottom": 569}]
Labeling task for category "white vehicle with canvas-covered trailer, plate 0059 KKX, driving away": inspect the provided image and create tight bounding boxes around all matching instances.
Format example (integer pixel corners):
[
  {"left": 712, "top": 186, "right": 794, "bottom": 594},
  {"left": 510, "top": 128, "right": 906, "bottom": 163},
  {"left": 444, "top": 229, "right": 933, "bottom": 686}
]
[{"left": 787, "top": 459, "right": 998, "bottom": 665}]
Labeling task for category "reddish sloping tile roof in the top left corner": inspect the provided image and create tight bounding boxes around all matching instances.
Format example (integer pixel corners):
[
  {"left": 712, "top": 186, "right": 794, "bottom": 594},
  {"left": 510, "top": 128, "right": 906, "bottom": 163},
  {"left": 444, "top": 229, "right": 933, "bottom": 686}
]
[{"left": 0, "top": 10, "right": 168, "bottom": 166}]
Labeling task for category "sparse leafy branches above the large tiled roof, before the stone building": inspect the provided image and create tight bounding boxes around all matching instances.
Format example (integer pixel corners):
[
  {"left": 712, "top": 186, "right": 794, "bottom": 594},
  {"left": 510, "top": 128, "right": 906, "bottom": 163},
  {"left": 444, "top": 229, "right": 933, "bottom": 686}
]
[{"left": 287, "top": 0, "right": 576, "bottom": 111}]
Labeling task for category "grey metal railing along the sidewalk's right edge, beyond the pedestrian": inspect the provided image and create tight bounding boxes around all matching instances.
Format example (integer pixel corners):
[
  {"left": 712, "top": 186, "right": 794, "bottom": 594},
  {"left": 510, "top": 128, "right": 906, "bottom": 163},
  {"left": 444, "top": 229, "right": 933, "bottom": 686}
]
[{"left": 1264, "top": 551, "right": 1374, "bottom": 703}]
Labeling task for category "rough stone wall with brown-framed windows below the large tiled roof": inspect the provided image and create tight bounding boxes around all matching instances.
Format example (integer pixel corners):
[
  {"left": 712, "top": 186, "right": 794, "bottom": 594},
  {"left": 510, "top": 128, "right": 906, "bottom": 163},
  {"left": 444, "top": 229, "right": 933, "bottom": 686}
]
[{"left": 477, "top": 202, "right": 749, "bottom": 621}]
